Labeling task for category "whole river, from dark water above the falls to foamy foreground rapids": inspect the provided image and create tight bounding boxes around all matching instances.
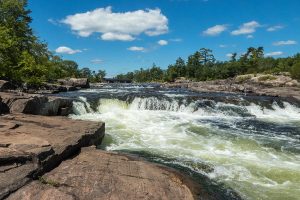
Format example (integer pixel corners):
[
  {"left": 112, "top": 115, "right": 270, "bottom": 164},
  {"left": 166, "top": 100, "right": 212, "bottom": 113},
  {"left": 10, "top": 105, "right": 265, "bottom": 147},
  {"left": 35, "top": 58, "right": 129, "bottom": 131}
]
[{"left": 55, "top": 84, "right": 300, "bottom": 200}]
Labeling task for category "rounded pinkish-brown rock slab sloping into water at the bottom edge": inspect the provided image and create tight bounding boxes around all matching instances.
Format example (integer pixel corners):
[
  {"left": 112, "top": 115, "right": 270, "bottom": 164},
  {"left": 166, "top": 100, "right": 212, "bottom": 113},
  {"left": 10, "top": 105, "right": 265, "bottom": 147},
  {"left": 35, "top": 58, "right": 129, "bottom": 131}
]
[{"left": 8, "top": 147, "right": 212, "bottom": 200}]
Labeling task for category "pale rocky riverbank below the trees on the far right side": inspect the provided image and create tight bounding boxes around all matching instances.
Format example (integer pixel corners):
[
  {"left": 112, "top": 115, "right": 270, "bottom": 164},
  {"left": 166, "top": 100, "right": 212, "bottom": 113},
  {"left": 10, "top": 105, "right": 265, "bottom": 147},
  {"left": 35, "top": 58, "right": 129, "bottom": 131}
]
[{"left": 162, "top": 74, "right": 300, "bottom": 101}]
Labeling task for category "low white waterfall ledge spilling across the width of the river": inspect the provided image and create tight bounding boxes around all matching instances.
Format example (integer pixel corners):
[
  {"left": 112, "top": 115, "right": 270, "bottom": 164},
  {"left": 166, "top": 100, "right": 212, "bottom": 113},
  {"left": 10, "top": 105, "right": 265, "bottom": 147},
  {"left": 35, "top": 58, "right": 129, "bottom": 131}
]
[{"left": 73, "top": 97, "right": 300, "bottom": 121}]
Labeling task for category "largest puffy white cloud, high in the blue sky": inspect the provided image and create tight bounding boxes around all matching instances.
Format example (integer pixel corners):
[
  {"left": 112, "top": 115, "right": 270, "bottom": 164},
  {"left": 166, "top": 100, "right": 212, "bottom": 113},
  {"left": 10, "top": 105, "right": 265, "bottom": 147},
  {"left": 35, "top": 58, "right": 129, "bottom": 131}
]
[{"left": 61, "top": 7, "right": 169, "bottom": 41}]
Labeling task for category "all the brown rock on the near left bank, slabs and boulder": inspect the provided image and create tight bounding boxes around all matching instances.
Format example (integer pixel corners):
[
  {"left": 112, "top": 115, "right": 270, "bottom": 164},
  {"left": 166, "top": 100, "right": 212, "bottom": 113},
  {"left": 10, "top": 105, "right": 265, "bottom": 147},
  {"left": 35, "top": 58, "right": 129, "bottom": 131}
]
[{"left": 0, "top": 93, "right": 216, "bottom": 200}]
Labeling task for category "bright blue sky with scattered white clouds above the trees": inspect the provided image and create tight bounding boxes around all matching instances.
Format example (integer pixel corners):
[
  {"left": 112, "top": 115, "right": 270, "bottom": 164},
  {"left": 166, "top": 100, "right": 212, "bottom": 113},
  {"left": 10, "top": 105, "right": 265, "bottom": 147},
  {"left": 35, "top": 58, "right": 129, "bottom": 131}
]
[{"left": 29, "top": 0, "right": 300, "bottom": 77}]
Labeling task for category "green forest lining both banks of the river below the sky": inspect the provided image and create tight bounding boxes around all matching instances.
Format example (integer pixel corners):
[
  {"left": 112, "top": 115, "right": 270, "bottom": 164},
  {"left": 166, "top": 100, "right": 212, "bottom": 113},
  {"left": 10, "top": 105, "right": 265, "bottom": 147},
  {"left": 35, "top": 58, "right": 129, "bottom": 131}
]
[{"left": 0, "top": 0, "right": 300, "bottom": 85}]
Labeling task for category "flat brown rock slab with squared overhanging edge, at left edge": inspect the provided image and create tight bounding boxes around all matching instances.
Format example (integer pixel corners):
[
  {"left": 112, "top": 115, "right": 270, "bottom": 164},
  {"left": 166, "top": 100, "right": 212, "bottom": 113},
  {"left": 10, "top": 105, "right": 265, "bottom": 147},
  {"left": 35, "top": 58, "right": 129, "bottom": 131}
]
[{"left": 0, "top": 114, "right": 104, "bottom": 199}]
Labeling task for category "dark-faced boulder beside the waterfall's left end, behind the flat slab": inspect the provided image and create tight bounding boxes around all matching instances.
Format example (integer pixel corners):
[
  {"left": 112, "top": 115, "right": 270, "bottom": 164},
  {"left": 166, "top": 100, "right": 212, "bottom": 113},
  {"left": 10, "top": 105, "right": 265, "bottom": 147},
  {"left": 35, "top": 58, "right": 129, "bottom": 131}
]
[{"left": 0, "top": 92, "right": 72, "bottom": 116}]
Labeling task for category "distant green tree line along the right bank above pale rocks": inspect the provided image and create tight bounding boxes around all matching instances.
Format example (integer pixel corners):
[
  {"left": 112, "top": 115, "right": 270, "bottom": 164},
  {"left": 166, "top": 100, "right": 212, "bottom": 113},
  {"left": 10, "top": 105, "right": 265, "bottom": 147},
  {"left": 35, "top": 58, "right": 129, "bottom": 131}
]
[{"left": 116, "top": 47, "right": 300, "bottom": 82}]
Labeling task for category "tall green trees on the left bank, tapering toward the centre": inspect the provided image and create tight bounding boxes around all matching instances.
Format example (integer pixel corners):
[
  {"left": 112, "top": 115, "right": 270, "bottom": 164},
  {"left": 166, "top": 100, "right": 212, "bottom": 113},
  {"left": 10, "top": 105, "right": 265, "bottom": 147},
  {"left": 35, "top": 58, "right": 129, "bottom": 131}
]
[{"left": 0, "top": 0, "right": 106, "bottom": 85}]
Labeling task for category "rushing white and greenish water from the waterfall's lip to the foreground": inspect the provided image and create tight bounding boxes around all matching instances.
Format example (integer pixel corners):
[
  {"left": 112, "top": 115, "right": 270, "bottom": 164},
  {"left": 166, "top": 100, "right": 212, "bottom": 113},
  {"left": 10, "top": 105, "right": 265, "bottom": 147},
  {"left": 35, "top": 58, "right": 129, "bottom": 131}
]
[{"left": 70, "top": 93, "right": 300, "bottom": 200}]
